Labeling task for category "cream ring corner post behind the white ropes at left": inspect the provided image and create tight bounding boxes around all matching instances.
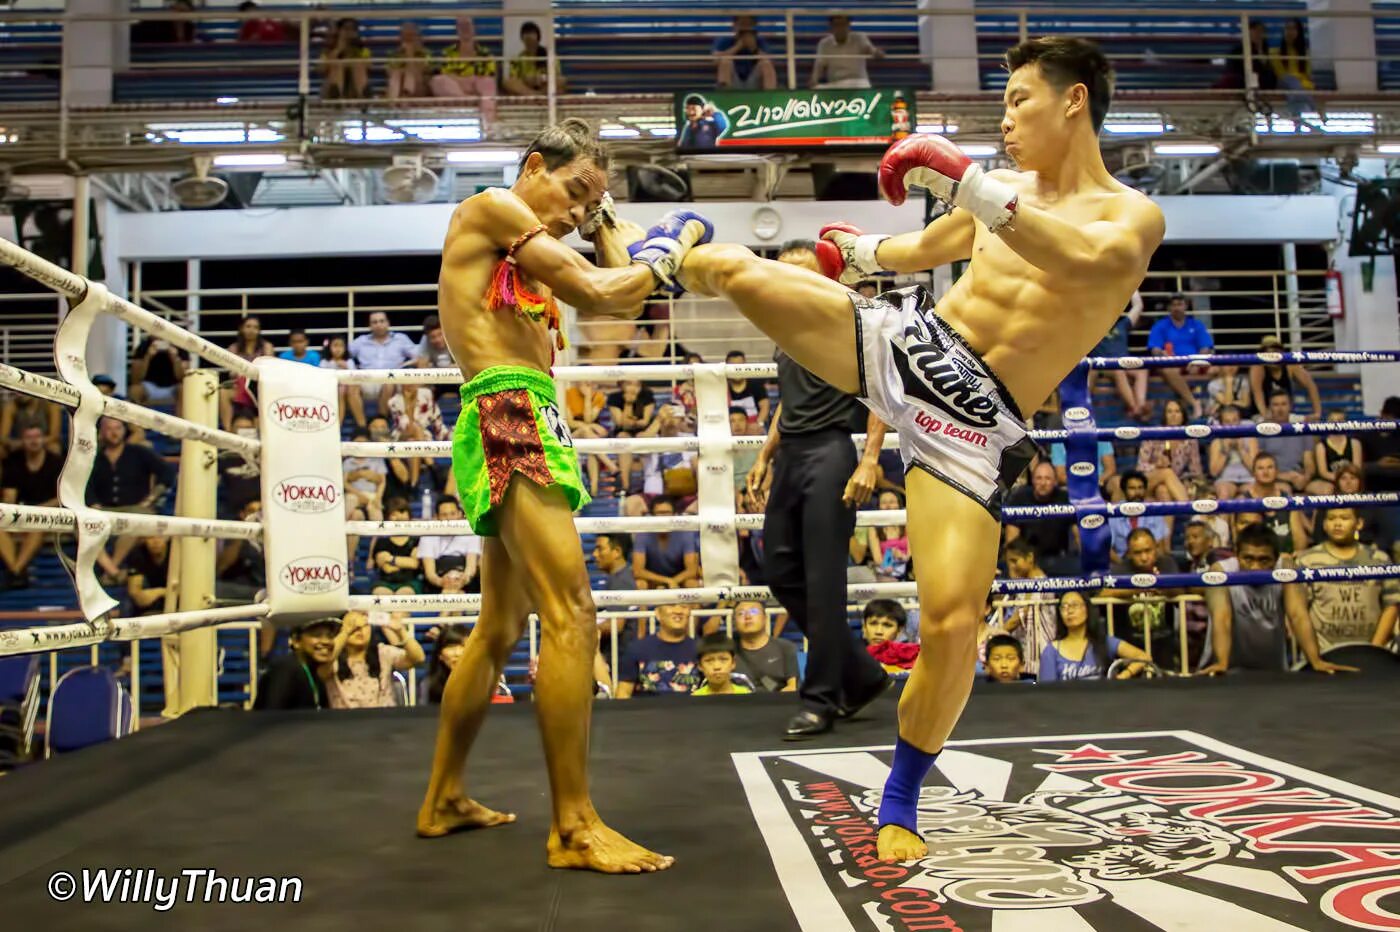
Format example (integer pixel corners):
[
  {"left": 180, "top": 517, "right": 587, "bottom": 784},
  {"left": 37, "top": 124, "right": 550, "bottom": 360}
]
[{"left": 176, "top": 369, "right": 218, "bottom": 715}]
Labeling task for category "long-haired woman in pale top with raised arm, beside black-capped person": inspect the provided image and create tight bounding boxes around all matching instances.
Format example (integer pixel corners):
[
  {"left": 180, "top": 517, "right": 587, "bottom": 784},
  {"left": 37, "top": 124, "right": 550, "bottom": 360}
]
[{"left": 325, "top": 612, "right": 424, "bottom": 708}]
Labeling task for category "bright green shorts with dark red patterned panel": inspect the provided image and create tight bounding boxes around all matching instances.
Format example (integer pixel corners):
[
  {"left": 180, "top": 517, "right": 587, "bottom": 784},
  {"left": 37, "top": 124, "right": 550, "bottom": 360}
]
[{"left": 452, "top": 365, "right": 591, "bottom": 537}]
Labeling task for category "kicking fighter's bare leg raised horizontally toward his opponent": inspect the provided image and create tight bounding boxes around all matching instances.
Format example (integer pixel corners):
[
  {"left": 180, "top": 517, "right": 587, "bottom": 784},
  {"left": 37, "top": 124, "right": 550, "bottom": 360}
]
[{"left": 678, "top": 243, "right": 861, "bottom": 395}]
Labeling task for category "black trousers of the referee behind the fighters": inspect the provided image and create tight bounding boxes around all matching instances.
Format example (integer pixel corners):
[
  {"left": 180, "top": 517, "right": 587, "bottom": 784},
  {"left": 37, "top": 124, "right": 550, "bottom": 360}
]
[{"left": 763, "top": 430, "right": 885, "bottom": 715}]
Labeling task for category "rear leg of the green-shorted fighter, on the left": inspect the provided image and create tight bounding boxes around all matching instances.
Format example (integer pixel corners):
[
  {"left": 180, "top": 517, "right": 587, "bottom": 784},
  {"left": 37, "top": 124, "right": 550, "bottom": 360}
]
[{"left": 417, "top": 528, "right": 531, "bottom": 838}]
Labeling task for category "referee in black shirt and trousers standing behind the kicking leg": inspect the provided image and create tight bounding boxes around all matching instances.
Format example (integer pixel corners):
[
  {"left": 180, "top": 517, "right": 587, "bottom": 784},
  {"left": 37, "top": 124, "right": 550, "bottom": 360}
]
[{"left": 748, "top": 239, "right": 889, "bottom": 739}]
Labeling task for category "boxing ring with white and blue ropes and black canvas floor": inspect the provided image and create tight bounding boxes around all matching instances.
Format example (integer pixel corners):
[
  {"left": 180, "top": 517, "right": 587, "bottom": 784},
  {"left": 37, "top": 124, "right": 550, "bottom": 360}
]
[{"left": 0, "top": 241, "right": 1400, "bottom": 932}]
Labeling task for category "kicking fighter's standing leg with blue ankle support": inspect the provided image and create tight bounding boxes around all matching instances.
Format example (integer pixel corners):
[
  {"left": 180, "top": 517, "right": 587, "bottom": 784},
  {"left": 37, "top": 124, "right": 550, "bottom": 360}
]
[{"left": 878, "top": 467, "right": 1001, "bottom": 861}]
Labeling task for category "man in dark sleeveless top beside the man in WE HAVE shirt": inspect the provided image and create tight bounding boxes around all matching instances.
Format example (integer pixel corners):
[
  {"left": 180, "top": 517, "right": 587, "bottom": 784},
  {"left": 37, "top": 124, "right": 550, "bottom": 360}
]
[{"left": 1200, "top": 525, "right": 1352, "bottom": 676}]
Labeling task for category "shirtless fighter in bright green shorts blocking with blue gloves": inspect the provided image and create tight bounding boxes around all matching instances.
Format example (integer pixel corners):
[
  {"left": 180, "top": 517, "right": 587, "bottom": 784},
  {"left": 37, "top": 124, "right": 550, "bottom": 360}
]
[{"left": 417, "top": 120, "right": 710, "bottom": 873}]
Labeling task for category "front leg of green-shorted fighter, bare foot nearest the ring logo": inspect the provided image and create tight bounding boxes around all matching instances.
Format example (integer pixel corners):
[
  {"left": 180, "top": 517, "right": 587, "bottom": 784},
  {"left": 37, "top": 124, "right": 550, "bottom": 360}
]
[{"left": 497, "top": 476, "right": 673, "bottom": 873}]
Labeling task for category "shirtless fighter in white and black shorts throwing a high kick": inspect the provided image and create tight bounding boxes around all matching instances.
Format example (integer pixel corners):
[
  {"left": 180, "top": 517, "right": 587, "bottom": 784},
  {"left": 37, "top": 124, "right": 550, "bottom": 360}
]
[{"left": 679, "top": 38, "right": 1163, "bottom": 861}]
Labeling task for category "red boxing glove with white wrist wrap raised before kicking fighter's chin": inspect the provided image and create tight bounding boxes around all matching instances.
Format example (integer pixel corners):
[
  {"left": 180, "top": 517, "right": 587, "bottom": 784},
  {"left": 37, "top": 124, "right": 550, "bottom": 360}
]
[{"left": 879, "top": 134, "right": 1016, "bottom": 232}]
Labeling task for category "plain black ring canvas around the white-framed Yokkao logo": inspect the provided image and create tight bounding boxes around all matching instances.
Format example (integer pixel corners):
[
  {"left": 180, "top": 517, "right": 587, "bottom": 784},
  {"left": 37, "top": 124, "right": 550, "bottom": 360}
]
[{"left": 0, "top": 660, "right": 1400, "bottom": 932}]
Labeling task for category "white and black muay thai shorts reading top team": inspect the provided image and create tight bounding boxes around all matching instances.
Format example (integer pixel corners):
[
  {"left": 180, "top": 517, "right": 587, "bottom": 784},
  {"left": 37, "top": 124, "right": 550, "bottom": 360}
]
[{"left": 851, "top": 285, "right": 1036, "bottom": 521}]
